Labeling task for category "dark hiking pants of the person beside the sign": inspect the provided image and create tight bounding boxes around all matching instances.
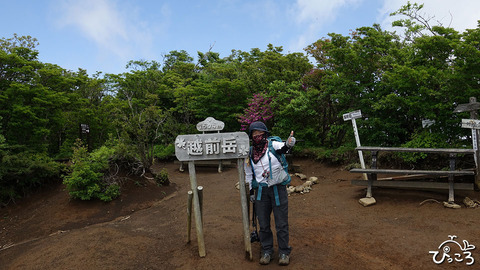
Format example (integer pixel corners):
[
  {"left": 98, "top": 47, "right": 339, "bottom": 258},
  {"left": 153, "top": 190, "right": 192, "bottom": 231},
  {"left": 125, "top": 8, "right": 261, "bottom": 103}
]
[{"left": 255, "top": 185, "right": 292, "bottom": 255}]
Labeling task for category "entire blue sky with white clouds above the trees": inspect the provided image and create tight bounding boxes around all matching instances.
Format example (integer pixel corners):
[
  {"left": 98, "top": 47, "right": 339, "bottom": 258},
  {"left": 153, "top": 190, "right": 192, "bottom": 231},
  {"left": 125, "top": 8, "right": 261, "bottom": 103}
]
[{"left": 0, "top": 0, "right": 480, "bottom": 74}]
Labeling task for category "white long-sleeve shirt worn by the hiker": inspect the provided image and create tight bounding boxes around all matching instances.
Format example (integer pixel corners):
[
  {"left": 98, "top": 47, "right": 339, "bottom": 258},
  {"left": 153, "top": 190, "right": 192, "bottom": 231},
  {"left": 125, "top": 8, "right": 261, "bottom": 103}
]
[{"left": 244, "top": 141, "right": 285, "bottom": 189}]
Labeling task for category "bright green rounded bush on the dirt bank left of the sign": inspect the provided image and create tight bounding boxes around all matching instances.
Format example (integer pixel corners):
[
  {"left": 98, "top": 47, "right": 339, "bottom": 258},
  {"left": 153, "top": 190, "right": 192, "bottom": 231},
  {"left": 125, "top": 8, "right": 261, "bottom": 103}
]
[{"left": 63, "top": 141, "right": 120, "bottom": 202}]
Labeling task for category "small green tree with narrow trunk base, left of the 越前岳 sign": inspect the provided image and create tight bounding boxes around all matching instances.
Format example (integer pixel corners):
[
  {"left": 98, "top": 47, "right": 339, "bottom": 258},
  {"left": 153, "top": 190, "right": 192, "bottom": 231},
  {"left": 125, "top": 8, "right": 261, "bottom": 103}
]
[{"left": 109, "top": 63, "right": 167, "bottom": 176}]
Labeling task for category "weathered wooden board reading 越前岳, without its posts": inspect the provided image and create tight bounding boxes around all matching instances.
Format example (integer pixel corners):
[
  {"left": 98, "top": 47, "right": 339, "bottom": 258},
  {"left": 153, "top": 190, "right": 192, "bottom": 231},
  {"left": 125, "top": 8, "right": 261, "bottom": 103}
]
[{"left": 175, "top": 132, "right": 250, "bottom": 161}]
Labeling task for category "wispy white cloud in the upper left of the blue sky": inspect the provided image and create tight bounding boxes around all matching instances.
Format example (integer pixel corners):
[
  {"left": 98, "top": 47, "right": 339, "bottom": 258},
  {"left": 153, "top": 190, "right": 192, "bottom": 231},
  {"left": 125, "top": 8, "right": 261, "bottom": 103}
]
[{"left": 57, "top": 0, "right": 158, "bottom": 67}]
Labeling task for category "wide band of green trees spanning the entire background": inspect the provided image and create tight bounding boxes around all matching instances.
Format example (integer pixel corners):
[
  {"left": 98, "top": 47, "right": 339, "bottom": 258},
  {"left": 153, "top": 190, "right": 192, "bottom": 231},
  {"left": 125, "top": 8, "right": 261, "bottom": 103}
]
[{"left": 0, "top": 3, "right": 480, "bottom": 175}]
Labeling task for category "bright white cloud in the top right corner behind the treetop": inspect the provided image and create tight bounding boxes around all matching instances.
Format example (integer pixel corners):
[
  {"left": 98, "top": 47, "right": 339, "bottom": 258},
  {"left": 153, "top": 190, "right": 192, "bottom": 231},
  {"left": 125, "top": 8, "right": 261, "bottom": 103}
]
[{"left": 378, "top": 0, "right": 480, "bottom": 32}]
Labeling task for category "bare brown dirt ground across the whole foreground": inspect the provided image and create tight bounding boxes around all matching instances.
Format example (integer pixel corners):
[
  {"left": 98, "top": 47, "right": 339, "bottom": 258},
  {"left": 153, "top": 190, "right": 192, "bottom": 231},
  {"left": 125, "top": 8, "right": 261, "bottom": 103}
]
[{"left": 0, "top": 159, "right": 480, "bottom": 269}]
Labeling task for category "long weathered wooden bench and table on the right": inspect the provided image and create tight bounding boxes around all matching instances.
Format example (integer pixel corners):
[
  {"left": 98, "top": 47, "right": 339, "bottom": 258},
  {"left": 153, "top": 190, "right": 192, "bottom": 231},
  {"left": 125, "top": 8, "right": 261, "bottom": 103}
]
[{"left": 350, "top": 146, "right": 475, "bottom": 203}]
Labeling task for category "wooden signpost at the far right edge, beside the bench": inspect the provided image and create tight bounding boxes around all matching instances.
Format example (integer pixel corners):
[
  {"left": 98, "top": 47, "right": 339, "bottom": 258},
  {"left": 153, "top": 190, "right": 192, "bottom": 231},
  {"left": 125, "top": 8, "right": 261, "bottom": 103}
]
[{"left": 453, "top": 97, "right": 480, "bottom": 189}]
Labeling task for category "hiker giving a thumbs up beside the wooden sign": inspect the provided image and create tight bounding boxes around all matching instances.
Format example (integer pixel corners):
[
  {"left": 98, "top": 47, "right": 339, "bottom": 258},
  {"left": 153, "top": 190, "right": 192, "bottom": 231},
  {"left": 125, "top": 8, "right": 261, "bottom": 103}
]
[{"left": 245, "top": 121, "right": 295, "bottom": 265}]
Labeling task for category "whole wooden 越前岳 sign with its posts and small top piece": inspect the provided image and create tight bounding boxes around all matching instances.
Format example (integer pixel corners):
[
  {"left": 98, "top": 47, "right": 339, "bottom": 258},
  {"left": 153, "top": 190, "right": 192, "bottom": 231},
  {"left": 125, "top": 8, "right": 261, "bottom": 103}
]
[{"left": 175, "top": 117, "right": 252, "bottom": 259}]
